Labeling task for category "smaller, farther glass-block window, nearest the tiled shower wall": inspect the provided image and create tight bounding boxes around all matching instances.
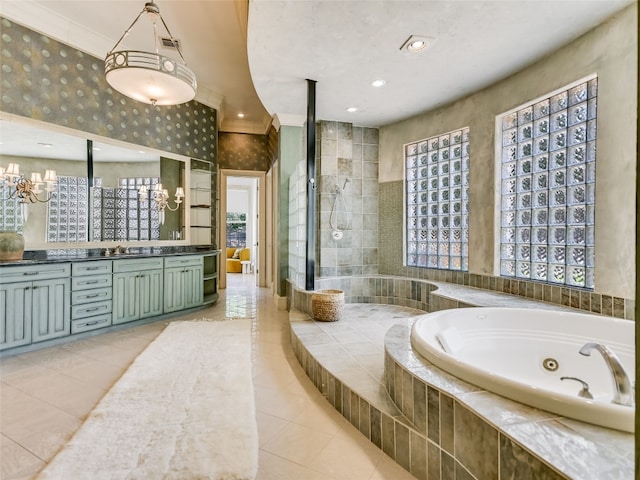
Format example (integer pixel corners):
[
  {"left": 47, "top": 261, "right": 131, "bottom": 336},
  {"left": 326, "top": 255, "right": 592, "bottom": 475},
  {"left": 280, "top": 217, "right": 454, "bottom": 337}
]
[{"left": 404, "top": 128, "right": 469, "bottom": 271}]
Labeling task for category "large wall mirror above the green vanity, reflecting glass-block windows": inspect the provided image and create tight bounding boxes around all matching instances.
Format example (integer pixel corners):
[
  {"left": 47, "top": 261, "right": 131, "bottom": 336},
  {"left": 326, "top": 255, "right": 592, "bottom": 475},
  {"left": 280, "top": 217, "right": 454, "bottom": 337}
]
[{"left": 0, "top": 114, "right": 190, "bottom": 249}]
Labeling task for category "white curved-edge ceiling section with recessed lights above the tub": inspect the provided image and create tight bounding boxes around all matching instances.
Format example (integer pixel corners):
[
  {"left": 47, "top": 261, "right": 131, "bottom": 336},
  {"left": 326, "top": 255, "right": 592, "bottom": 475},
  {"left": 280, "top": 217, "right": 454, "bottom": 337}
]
[{"left": 248, "top": 0, "right": 633, "bottom": 127}]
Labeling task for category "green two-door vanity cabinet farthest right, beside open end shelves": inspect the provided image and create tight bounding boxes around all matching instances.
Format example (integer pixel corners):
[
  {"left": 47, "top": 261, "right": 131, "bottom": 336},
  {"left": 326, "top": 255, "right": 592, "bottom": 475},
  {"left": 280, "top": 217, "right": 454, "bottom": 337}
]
[{"left": 164, "top": 255, "right": 203, "bottom": 313}]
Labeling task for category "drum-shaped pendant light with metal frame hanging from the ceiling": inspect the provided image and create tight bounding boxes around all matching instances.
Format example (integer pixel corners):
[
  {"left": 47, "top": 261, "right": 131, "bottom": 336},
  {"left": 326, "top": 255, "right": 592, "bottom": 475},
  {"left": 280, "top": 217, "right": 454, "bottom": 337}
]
[{"left": 104, "top": 2, "right": 197, "bottom": 105}]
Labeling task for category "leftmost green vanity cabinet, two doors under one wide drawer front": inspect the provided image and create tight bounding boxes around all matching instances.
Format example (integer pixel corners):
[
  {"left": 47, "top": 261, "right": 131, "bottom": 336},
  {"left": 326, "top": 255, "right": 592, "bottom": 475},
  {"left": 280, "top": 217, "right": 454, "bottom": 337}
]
[{"left": 0, "top": 263, "right": 71, "bottom": 350}]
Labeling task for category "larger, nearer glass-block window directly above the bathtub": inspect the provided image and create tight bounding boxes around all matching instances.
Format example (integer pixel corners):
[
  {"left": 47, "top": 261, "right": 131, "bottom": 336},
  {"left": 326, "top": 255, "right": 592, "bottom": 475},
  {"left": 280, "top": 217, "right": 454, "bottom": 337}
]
[{"left": 499, "top": 78, "right": 598, "bottom": 288}]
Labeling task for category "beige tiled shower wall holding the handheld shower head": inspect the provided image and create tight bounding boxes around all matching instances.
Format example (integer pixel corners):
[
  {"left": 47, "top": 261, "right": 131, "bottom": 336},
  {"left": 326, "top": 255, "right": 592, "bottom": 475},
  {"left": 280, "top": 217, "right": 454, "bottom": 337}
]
[{"left": 316, "top": 121, "right": 378, "bottom": 277}]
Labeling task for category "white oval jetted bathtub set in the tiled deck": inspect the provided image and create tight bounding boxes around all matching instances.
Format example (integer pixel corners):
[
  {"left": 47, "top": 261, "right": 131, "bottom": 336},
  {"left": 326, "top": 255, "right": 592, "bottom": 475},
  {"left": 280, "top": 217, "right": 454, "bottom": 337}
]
[{"left": 411, "top": 307, "right": 635, "bottom": 432}]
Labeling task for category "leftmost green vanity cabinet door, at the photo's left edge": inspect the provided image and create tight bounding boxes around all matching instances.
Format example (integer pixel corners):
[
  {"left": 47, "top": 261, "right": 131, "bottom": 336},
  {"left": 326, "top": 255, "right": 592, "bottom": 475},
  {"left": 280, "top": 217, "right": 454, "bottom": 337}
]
[{"left": 0, "top": 282, "right": 32, "bottom": 350}]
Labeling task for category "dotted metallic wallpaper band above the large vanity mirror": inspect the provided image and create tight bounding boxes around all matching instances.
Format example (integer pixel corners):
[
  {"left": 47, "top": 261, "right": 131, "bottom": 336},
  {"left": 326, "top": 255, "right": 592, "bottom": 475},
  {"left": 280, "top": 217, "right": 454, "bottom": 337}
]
[{"left": 0, "top": 17, "right": 217, "bottom": 165}]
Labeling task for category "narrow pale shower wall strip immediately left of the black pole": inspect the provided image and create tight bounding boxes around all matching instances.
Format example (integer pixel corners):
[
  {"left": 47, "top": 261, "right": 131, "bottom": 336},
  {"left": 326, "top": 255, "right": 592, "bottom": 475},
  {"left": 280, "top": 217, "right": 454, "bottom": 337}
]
[{"left": 289, "top": 161, "right": 307, "bottom": 289}]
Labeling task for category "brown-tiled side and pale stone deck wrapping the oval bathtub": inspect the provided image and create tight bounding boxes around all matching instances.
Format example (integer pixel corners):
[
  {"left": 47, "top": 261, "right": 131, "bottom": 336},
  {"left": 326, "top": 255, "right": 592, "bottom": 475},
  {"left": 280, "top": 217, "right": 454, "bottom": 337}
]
[{"left": 385, "top": 325, "right": 634, "bottom": 480}]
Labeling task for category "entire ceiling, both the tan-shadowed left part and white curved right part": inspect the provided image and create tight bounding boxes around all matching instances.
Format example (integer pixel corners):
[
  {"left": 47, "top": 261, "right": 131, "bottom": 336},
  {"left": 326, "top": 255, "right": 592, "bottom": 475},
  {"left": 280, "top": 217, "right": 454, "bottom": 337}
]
[{"left": 0, "top": 0, "right": 634, "bottom": 137}]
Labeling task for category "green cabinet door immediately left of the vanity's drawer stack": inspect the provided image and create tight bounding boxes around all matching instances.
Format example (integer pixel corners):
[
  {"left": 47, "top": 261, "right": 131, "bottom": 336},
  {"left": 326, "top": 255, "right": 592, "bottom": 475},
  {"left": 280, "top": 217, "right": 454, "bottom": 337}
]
[{"left": 31, "top": 278, "right": 71, "bottom": 342}]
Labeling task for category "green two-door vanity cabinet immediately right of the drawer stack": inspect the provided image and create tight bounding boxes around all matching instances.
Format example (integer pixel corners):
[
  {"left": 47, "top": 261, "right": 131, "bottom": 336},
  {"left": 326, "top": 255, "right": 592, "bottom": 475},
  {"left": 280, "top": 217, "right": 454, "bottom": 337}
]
[{"left": 112, "top": 257, "right": 164, "bottom": 325}]
